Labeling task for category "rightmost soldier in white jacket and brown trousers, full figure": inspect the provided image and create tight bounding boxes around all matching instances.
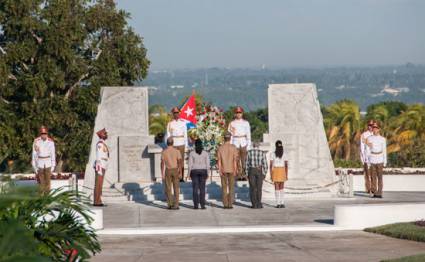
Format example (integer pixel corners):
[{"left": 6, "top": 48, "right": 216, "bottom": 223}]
[{"left": 366, "top": 123, "right": 387, "bottom": 198}]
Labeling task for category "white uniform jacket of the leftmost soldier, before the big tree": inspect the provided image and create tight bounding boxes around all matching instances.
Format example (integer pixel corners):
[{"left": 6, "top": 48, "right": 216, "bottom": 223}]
[{"left": 31, "top": 137, "right": 56, "bottom": 171}]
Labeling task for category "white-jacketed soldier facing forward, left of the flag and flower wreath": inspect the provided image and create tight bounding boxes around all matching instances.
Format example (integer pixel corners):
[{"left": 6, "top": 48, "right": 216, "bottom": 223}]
[{"left": 165, "top": 107, "right": 188, "bottom": 182}]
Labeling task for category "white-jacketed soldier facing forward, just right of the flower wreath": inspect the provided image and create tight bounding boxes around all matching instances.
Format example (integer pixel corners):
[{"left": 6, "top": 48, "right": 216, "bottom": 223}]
[{"left": 228, "top": 106, "right": 251, "bottom": 179}]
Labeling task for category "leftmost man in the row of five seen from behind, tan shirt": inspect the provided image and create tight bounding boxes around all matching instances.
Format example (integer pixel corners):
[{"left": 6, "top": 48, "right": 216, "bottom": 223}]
[{"left": 161, "top": 137, "right": 183, "bottom": 209}]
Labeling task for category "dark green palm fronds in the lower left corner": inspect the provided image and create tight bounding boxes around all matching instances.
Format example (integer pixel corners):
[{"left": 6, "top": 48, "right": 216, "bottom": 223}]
[{"left": 0, "top": 182, "right": 101, "bottom": 261}]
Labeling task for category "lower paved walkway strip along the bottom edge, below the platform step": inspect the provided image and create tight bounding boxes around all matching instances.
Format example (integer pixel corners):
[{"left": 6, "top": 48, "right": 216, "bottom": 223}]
[{"left": 91, "top": 231, "right": 425, "bottom": 262}]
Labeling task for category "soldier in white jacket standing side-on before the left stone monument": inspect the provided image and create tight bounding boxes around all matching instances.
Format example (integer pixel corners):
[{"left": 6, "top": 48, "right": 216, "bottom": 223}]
[{"left": 93, "top": 128, "right": 109, "bottom": 206}]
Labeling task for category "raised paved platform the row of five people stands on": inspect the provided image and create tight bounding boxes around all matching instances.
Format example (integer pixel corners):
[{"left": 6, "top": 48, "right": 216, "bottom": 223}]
[{"left": 103, "top": 192, "right": 425, "bottom": 229}]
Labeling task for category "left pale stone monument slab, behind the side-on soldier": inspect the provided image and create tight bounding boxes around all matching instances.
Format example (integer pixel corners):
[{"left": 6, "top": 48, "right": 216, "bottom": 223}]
[{"left": 84, "top": 87, "right": 154, "bottom": 195}]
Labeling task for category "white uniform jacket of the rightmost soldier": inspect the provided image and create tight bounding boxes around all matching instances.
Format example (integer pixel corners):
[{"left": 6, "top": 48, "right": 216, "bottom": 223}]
[{"left": 366, "top": 135, "right": 387, "bottom": 166}]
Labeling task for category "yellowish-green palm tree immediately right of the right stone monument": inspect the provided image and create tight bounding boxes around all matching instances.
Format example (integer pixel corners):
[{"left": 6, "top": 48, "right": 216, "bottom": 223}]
[{"left": 324, "top": 100, "right": 361, "bottom": 160}]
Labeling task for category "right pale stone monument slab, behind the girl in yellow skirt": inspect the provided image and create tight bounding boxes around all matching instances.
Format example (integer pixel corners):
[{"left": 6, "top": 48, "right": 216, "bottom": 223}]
[{"left": 264, "top": 84, "right": 337, "bottom": 193}]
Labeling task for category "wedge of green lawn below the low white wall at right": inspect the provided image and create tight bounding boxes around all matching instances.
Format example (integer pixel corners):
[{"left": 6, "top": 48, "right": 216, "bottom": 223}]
[{"left": 365, "top": 222, "right": 425, "bottom": 242}]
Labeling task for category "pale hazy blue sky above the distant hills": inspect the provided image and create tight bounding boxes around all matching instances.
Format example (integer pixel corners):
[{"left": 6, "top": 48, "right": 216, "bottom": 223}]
[{"left": 116, "top": 0, "right": 425, "bottom": 70}]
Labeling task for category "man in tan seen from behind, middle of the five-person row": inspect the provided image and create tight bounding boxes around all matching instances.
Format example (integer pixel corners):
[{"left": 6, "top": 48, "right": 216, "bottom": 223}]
[{"left": 217, "top": 132, "right": 238, "bottom": 209}]
